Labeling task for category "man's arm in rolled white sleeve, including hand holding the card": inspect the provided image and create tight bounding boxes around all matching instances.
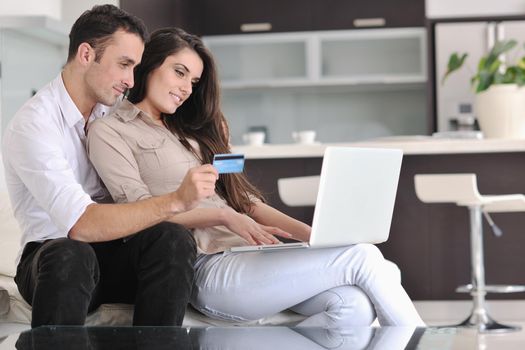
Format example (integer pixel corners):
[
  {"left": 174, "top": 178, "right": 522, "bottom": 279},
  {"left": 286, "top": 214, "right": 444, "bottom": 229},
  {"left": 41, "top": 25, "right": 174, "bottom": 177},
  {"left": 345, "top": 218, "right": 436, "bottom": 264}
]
[{"left": 3, "top": 110, "right": 218, "bottom": 242}]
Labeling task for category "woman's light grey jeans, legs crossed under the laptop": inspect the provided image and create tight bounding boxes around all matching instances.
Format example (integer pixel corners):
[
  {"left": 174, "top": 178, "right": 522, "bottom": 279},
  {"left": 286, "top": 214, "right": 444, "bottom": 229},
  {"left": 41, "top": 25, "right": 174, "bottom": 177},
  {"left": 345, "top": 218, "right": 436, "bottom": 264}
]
[{"left": 191, "top": 244, "right": 424, "bottom": 327}]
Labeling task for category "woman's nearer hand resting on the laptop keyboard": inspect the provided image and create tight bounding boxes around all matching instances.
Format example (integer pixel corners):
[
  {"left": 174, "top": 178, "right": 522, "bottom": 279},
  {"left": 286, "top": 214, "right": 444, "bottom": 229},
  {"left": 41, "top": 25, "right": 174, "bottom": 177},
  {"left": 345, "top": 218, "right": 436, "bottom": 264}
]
[{"left": 224, "top": 208, "right": 292, "bottom": 245}]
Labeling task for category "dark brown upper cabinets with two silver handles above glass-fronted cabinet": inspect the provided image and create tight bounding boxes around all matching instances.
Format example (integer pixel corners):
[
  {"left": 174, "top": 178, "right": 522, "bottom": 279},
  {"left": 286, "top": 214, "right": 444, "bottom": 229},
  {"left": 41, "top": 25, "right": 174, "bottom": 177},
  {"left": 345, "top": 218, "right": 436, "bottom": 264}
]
[{"left": 202, "top": 0, "right": 425, "bottom": 35}]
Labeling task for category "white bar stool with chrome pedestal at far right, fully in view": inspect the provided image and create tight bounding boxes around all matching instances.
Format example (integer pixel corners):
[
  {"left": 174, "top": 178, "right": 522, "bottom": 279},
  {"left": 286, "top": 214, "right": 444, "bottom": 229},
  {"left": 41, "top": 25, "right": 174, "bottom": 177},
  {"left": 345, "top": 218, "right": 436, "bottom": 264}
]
[{"left": 414, "top": 174, "right": 525, "bottom": 333}]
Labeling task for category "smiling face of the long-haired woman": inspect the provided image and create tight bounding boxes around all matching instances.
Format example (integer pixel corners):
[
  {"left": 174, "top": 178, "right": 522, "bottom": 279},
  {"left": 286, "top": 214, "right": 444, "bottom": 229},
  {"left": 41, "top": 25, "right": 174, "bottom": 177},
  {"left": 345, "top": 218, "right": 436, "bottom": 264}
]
[{"left": 144, "top": 48, "right": 204, "bottom": 117}]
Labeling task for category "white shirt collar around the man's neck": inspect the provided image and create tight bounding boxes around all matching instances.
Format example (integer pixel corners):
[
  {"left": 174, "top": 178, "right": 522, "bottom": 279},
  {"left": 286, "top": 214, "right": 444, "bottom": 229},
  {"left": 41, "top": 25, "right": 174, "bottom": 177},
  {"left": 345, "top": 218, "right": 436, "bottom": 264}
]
[{"left": 51, "top": 73, "right": 110, "bottom": 128}]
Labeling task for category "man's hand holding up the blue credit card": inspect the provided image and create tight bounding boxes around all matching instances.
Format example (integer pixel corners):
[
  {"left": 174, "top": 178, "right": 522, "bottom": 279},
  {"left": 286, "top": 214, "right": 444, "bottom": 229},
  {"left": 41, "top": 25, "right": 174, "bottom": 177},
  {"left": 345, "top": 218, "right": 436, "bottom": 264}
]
[{"left": 173, "top": 164, "right": 219, "bottom": 213}]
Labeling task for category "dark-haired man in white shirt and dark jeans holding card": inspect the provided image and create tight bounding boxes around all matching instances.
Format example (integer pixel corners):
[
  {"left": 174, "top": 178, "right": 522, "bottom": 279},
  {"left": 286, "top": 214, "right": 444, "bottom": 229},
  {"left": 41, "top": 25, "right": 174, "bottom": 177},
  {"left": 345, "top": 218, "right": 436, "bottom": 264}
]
[{"left": 3, "top": 5, "right": 218, "bottom": 327}]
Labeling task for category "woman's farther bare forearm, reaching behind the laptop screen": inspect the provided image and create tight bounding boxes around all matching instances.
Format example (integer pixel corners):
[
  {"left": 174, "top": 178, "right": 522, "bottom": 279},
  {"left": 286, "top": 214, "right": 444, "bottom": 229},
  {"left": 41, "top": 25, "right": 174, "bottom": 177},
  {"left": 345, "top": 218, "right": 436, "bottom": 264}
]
[{"left": 250, "top": 202, "right": 311, "bottom": 242}]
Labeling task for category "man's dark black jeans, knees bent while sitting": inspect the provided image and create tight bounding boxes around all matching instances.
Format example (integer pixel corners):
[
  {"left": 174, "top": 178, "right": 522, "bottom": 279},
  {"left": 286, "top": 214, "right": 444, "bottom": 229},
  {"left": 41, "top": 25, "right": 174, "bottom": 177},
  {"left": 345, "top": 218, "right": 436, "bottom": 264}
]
[{"left": 15, "top": 222, "right": 196, "bottom": 327}]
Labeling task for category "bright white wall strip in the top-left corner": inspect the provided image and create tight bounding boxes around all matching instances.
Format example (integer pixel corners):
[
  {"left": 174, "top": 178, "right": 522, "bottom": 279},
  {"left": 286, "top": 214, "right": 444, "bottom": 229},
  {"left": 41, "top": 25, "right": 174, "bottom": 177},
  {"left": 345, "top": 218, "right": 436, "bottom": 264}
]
[{"left": 0, "top": 0, "right": 61, "bottom": 19}]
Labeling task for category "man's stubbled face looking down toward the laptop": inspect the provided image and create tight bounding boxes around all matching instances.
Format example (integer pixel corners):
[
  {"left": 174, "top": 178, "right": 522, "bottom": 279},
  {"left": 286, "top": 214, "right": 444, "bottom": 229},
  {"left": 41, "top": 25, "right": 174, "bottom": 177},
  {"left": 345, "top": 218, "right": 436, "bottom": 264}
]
[{"left": 85, "top": 30, "right": 144, "bottom": 106}]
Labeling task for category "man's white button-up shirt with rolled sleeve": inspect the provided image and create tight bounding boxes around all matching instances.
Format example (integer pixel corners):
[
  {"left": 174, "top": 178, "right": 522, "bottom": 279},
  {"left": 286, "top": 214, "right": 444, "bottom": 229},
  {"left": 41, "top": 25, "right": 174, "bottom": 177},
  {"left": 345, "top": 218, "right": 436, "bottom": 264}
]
[{"left": 2, "top": 74, "right": 109, "bottom": 263}]
